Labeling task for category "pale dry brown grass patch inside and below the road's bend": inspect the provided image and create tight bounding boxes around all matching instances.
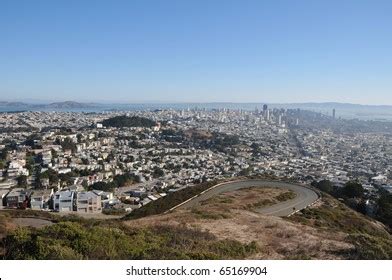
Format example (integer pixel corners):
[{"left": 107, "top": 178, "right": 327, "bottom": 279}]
[{"left": 125, "top": 188, "right": 353, "bottom": 259}]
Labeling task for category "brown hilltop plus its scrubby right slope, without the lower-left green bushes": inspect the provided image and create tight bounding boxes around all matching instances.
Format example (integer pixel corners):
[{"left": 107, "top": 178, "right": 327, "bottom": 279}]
[{"left": 126, "top": 189, "right": 392, "bottom": 259}]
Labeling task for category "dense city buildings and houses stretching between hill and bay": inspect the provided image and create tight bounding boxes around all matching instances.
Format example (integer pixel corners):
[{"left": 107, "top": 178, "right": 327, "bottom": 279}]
[{"left": 0, "top": 105, "right": 392, "bottom": 217}]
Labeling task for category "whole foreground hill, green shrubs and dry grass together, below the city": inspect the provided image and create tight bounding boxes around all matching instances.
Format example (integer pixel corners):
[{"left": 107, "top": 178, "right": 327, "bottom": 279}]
[{"left": 0, "top": 185, "right": 392, "bottom": 259}]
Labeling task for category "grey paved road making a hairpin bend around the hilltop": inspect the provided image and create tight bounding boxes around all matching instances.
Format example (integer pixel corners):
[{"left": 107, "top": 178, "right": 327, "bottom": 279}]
[{"left": 178, "top": 180, "right": 318, "bottom": 217}]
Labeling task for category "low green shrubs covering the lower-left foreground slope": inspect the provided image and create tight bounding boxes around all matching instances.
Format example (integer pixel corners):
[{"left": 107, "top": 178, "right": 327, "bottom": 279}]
[{"left": 0, "top": 212, "right": 259, "bottom": 260}]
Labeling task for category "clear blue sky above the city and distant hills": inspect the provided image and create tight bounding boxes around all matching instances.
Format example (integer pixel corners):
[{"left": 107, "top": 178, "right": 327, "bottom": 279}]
[{"left": 0, "top": 0, "right": 392, "bottom": 104}]
